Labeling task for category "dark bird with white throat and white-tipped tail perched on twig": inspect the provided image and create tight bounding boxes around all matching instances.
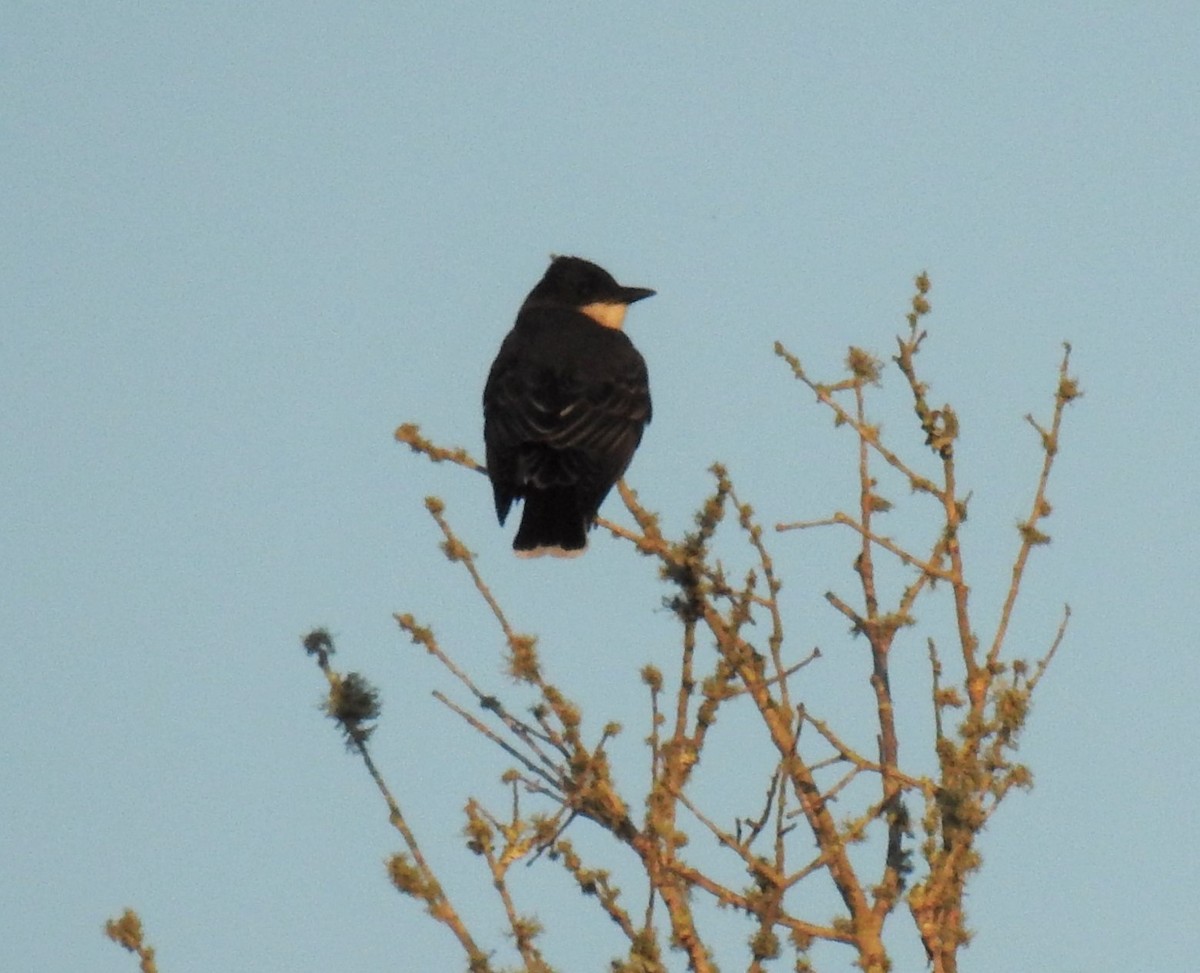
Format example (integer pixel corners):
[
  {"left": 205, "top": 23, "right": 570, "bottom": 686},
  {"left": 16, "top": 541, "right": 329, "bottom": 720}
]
[{"left": 484, "top": 257, "right": 655, "bottom": 558}]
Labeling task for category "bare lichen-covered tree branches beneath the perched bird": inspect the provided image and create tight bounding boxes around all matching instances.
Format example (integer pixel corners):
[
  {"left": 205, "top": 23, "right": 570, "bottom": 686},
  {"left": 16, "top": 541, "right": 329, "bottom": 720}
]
[{"left": 110, "top": 274, "right": 1081, "bottom": 973}]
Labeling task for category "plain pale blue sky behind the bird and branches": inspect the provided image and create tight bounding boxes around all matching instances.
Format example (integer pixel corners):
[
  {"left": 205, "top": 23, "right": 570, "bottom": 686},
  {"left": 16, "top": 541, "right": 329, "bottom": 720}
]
[{"left": 0, "top": 0, "right": 1200, "bottom": 973}]
